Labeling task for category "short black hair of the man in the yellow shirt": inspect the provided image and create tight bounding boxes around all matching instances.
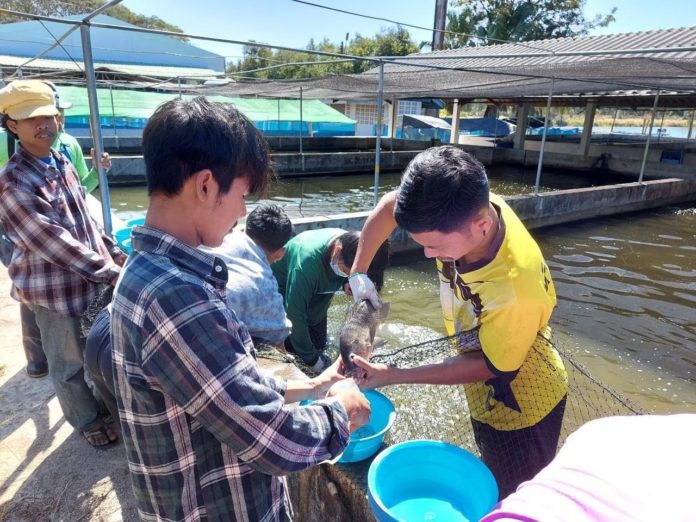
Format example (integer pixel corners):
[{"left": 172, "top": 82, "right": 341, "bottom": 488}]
[{"left": 394, "top": 145, "right": 490, "bottom": 233}]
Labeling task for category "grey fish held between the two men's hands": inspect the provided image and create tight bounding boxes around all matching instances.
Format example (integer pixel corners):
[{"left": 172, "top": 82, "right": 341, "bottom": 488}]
[{"left": 339, "top": 299, "right": 389, "bottom": 377}]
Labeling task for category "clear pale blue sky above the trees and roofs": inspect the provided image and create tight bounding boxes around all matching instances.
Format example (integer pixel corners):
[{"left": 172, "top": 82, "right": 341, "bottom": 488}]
[{"left": 122, "top": 0, "right": 696, "bottom": 61}]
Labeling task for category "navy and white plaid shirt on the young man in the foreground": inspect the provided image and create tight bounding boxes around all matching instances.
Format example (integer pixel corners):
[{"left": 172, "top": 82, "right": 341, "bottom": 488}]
[{"left": 112, "top": 227, "right": 349, "bottom": 521}]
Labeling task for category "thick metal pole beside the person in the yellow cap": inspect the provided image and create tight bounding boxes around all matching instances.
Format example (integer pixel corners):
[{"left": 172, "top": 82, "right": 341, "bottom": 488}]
[{"left": 80, "top": 24, "right": 111, "bottom": 236}]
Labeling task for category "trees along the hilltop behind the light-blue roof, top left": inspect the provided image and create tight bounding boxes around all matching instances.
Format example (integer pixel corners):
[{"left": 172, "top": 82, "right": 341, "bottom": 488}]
[{"left": 0, "top": 0, "right": 183, "bottom": 39}]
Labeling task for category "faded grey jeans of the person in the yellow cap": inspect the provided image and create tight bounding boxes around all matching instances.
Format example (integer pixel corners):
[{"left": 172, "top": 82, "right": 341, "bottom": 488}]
[{"left": 29, "top": 305, "right": 99, "bottom": 431}]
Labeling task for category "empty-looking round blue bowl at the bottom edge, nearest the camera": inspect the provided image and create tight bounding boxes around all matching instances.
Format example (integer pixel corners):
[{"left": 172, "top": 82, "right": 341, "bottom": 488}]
[{"left": 367, "top": 440, "right": 498, "bottom": 522}]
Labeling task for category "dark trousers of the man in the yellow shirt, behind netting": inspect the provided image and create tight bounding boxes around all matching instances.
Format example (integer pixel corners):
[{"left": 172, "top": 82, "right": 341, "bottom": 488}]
[{"left": 471, "top": 397, "right": 567, "bottom": 499}]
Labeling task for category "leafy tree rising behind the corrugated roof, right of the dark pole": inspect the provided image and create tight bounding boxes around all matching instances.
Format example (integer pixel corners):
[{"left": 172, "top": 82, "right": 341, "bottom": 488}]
[{"left": 445, "top": 0, "right": 616, "bottom": 49}]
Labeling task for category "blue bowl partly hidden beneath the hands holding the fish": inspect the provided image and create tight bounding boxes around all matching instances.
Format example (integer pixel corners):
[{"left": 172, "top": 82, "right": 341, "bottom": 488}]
[{"left": 300, "top": 390, "right": 396, "bottom": 463}]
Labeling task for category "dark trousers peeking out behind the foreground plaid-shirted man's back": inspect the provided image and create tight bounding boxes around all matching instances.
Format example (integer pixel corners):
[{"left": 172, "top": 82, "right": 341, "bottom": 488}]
[{"left": 85, "top": 308, "right": 118, "bottom": 421}]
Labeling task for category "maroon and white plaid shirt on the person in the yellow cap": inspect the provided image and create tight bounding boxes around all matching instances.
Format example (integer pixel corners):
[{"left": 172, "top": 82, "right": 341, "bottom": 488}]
[{"left": 0, "top": 144, "right": 125, "bottom": 317}]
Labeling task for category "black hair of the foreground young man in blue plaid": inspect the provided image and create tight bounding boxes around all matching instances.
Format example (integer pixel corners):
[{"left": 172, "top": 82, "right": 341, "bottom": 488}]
[{"left": 143, "top": 96, "right": 270, "bottom": 196}]
